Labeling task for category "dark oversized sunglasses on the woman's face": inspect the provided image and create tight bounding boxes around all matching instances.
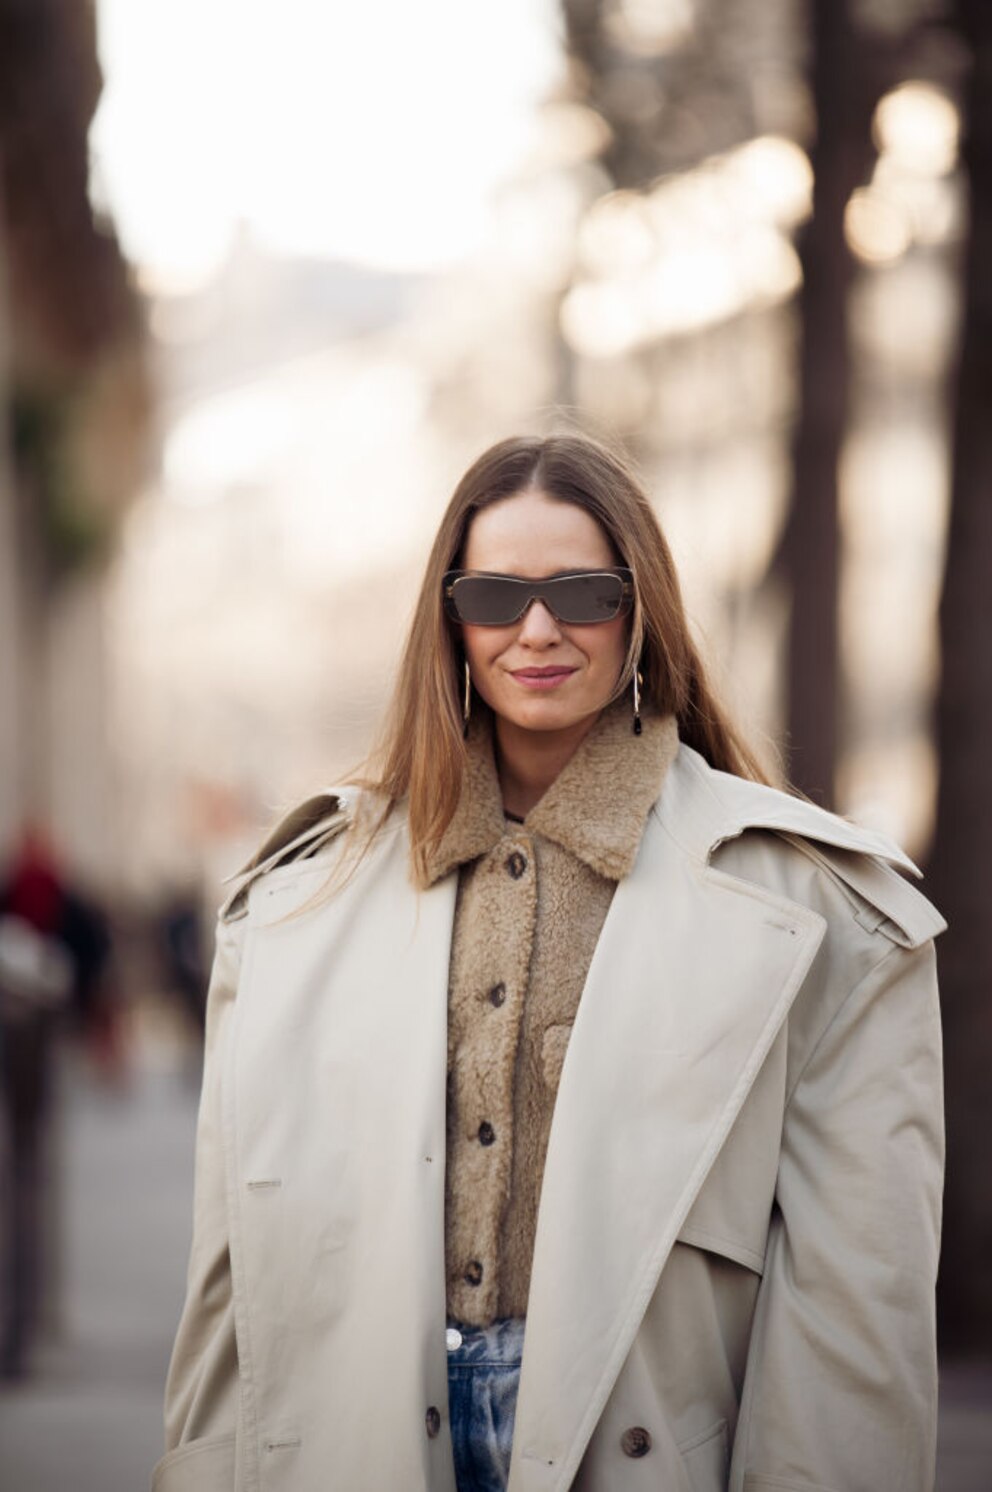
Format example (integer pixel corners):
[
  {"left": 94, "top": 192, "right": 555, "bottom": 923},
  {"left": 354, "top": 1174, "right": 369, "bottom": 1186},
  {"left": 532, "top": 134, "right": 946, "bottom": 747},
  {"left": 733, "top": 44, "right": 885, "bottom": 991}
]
[{"left": 443, "top": 565, "right": 634, "bottom": 627}]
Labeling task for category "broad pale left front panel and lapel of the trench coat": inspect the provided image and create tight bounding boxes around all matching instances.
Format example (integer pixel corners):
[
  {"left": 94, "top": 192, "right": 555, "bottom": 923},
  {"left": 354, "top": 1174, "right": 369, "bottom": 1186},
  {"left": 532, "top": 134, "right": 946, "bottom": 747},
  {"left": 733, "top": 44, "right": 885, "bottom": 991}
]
[{"left": 224, "top": 831, "right": 456, "bottom": 1492}]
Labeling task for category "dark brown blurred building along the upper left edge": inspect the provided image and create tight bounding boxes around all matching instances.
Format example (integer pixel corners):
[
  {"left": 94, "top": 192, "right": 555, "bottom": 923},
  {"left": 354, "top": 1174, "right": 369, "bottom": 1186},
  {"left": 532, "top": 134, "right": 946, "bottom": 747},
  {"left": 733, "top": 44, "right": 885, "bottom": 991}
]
[{"left": 0, "top": 0, "right": 149, "bottom": 886}]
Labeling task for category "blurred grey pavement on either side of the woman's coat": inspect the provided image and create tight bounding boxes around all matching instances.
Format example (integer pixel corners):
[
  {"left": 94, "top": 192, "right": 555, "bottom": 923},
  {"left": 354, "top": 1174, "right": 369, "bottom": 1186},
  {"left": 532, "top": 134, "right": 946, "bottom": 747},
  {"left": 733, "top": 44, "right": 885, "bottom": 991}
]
[{"left": 0, "top": 1022, "right": 992, "bottom": 1492}]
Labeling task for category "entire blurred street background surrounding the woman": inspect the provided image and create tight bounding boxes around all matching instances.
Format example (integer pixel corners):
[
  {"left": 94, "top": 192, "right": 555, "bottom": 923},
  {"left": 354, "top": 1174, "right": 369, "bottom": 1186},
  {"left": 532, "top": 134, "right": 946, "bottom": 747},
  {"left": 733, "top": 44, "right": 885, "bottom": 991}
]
[{"left": 0, "top": 0, "right": 992, "bottom": 1492}]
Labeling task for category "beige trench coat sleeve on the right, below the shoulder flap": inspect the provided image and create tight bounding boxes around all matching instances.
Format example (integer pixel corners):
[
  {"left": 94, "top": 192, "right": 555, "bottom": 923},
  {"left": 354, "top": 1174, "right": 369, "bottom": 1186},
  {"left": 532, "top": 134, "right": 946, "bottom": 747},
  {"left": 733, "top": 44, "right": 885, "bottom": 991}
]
[{"left": 729, "top": 941, "right": 943, "bottom": 1492}]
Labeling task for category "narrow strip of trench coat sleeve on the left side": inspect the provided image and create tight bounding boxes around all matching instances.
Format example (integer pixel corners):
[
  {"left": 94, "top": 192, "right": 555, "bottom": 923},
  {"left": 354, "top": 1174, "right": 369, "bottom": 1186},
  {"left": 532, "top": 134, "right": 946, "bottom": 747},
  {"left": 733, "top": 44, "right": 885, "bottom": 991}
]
[{"left": 152, "top": 921, "right": 245, "bottom": 1492}]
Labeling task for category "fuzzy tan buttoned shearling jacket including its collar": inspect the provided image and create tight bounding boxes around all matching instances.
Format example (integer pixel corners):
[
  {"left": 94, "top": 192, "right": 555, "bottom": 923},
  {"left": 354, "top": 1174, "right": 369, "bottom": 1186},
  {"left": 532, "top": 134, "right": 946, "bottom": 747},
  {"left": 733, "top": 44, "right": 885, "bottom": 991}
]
[{"left": 430, "top": 701, "right": 679, "bottom": 1326}]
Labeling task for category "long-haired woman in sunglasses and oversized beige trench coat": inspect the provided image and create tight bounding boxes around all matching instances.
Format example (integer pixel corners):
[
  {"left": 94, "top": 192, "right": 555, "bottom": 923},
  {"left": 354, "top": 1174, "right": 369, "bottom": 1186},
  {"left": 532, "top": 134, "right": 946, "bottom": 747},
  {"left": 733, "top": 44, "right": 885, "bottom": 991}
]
[{"left": 155, "top": 437, "right": 943, "bottom": 1492}]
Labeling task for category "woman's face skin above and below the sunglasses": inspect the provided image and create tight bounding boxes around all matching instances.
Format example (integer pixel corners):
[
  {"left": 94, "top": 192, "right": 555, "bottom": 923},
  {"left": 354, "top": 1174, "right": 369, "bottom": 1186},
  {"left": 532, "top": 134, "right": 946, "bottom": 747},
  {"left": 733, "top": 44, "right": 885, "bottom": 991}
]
[{"left": 461, "top": 488, "right": 627, "bottom": 731}]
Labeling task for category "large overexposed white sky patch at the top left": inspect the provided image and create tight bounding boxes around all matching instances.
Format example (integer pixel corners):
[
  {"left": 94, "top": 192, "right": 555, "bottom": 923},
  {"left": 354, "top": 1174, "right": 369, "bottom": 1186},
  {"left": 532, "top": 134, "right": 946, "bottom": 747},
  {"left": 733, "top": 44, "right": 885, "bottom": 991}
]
[{"left": 91, "top": 0, "right": 560, "bottom": 283}]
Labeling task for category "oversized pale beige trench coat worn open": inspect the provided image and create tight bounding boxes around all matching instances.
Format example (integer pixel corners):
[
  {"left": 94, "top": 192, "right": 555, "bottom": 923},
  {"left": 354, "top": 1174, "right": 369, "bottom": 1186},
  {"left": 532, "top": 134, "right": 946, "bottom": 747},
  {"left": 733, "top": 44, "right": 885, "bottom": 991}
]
[{"left": 154, "top": 746, "right": 943, "bottom": 1492}]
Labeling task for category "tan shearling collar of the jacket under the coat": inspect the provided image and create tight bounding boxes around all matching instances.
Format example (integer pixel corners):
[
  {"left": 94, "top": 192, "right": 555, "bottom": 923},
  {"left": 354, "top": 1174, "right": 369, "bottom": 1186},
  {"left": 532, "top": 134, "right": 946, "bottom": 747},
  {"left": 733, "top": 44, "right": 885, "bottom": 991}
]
[{"left": 427, "top": 700, "right": 679, "bottom": 885}]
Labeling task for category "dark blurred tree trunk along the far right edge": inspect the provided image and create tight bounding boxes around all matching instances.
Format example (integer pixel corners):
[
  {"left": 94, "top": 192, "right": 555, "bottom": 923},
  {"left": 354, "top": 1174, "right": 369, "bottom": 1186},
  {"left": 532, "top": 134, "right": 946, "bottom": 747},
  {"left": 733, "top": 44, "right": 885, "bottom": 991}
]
[{"left": 931, "top": 0, "right": 992, "bottom": 1352}]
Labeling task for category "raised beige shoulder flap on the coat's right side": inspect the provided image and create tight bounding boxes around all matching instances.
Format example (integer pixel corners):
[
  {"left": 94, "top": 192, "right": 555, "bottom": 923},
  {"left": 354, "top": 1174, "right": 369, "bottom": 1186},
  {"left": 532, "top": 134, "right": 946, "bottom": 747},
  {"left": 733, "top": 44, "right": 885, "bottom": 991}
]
[{"left": 712, "top": 773, "right": 947, "bottom": 947}]
